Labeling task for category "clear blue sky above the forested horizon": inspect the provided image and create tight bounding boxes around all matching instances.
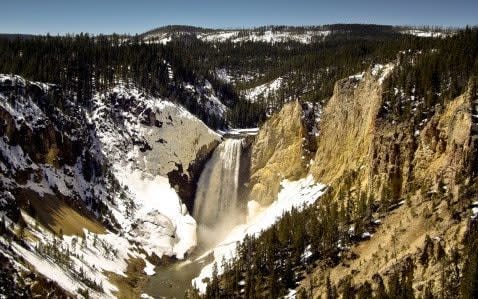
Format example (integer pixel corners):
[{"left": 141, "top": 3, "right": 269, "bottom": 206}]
[{"left": 0, "top": 0, "right": 478, "bottom": 34}]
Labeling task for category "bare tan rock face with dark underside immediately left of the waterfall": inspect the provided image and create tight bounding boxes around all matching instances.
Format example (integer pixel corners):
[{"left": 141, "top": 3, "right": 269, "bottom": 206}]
[{"left": 139, "top": 102, "right": 221, "bottom": 212}]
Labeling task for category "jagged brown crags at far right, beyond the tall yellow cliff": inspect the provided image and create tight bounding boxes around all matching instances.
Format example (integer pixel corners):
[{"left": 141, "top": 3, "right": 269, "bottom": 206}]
[{"left": 368, "top": 93, "right": 472, "bottom": 203}]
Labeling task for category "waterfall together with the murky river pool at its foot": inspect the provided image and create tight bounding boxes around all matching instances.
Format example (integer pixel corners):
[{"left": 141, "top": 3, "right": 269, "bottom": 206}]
[{"left": 147, "top": 138, "right": 244, "bottom": 298}]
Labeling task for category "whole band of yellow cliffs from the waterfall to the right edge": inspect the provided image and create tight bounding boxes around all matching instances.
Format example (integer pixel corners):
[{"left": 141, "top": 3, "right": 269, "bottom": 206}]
[{"left": 249, "top": 65, "right": 472, "bottom": 205}]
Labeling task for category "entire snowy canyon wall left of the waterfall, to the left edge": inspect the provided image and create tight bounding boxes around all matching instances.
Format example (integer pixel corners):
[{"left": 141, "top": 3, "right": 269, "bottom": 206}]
[{"left": 0, "top": 75, "right": 221, "bottom": 298}]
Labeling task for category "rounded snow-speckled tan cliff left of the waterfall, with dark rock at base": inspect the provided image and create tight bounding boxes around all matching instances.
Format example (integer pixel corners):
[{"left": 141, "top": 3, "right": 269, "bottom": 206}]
[{"left": 91, "top": 87, "right": 220, "bottom": 212}]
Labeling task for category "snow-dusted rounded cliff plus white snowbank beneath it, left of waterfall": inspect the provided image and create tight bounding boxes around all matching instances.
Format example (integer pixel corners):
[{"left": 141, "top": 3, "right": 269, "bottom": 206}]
[{"left": 90, "top": 84, "right": 220, "bottom": 259}]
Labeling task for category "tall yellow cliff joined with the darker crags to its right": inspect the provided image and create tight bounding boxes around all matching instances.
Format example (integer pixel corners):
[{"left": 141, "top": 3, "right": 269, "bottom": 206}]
[{"left": 310, "top": 64, "right": 473, "bottom": 200}]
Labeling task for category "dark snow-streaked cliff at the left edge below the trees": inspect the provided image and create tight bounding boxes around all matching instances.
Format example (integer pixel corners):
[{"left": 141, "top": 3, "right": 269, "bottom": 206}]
[{"left": 0, "top": 77, "right": 84, "bottom": 167}]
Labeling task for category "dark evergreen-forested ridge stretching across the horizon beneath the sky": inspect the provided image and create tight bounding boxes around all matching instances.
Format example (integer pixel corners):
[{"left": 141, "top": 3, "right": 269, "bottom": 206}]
[{"left": 0, "top": 24, "right": 478, "bottom": 127}]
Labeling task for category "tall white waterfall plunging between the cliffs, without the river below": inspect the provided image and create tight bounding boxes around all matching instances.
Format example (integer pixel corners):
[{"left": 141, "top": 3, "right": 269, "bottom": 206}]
[{"left": 193, "top": 138, "right": 242, "bottom": 229}]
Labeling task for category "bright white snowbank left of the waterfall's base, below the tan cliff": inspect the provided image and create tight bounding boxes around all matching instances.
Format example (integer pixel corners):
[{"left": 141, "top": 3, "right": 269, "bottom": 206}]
[{"left": 114, "top": 165, "right": 196, "bottom": 259}]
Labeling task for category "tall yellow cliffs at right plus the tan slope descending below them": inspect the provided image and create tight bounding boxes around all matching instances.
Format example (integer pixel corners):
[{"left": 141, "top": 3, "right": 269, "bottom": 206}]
[{"left": 302, "top": 69, "right": 477, "bottom": 298}]
